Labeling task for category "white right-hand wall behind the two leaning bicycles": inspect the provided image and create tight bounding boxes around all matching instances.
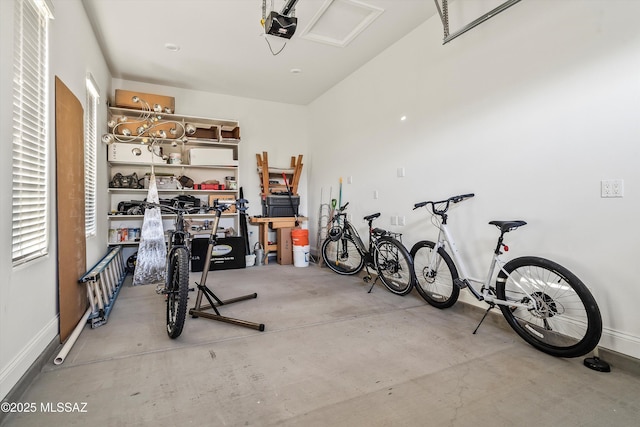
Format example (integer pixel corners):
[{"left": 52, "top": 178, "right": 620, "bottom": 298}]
[{"left": 307, "top": 0, "right": 640, "bottom": 357}]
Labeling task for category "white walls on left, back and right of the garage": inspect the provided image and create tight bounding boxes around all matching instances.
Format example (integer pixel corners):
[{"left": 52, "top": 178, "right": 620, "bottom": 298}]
[{"left": 0, "top": 0, "right": 640, "bottom": 397}]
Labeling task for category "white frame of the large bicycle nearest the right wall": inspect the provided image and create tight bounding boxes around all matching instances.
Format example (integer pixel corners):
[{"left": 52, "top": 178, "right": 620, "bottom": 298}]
[{"left": 429, "top": 222, "right": 536, "bottom": 310}]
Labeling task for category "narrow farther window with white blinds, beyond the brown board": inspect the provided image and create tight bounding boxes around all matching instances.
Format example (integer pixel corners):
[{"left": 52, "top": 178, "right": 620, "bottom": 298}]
[{"left": 84, "top": 74, "right": 100, "bottom": 237}]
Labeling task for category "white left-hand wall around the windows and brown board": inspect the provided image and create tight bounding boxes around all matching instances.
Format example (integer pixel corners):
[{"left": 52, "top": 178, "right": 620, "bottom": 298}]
[{"left": 0, "top": 0, "right": 111, "bottom": 398}]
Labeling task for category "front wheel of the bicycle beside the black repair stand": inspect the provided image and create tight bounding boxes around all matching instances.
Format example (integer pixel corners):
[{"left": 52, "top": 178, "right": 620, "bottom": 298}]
[{"left": 167, "top": 248, "right": 189, "bottom": 338}]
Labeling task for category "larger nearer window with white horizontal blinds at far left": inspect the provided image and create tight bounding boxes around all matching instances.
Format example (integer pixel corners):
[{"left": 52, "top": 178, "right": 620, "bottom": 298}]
[{"left": 11, "top": 0, "right": 53, "bottom": 265}]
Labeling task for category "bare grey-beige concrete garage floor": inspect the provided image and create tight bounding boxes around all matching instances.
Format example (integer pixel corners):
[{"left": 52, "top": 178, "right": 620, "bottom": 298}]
[{"left": 2, "top": 264, "right": 640, "bottom": 427}]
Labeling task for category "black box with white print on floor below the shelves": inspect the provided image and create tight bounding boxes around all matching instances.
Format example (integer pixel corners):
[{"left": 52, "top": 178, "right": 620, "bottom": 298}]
[{"left": 191, "top": 237, "right": 246, "bottom": 271}]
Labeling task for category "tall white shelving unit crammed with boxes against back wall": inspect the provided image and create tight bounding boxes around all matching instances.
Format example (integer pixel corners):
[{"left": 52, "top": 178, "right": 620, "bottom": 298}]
[{"left": 107, "top": 101, "right": 240, "bottom": 245}]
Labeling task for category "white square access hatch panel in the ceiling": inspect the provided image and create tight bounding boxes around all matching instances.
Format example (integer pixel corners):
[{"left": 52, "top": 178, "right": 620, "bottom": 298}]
[{"left": 301, "top": 0, "right": 384, "bottom": 47}]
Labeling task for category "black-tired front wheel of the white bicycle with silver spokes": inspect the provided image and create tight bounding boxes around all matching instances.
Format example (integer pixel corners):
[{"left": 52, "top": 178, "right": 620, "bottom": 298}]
[{"left": 411, "top": 240, "right": 460, "bottom": 308}]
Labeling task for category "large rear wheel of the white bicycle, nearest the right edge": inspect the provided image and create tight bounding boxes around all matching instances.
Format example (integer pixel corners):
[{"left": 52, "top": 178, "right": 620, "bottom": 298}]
[{"left": 496, "top": 257, "right": 602, "bottom": 357}]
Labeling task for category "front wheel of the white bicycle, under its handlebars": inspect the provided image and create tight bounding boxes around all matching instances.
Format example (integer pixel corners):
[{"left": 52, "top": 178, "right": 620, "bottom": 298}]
[{"left": 411, "top": 240, "right": 460, "bottom": 309}]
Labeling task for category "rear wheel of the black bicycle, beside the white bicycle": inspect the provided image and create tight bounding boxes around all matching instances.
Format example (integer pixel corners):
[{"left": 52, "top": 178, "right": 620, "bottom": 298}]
[{"left": 374, "top": 236, "right": 414, "bottom": 295}]
